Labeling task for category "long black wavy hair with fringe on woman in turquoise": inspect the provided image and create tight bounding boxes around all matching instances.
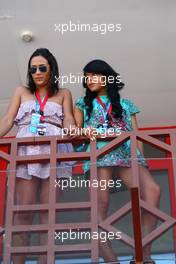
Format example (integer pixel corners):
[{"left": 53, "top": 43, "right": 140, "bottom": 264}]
[{"left": 83, "top": 60, "right": 124, "bottom": 119}]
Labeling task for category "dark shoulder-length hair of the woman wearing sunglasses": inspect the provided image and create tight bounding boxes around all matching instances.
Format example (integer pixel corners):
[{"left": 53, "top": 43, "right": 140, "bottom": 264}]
[{"left": 27, "top": 48, "right": 59, "bottom": 97}]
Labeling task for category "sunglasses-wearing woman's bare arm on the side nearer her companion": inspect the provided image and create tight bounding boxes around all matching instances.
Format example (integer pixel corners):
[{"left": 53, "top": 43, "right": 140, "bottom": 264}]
[{"left": 63, "top": 89, "right": 75, "bottom": 130}]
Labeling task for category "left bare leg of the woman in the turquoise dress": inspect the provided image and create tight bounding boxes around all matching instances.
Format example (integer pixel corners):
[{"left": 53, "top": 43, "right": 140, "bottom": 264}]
[{"left": 90, "top": 167, "right": 117, "bottom": 262}]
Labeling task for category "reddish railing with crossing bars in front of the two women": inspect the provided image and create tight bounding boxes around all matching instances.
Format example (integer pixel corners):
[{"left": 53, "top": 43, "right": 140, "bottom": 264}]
[{"left": 0, "top": 128, "right": 176, "bottom": 264}]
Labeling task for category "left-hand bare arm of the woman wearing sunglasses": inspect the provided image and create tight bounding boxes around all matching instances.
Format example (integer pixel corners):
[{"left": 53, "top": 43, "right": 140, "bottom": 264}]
[{"left": 0, "top": 87, "right": 22, "bottom": 137}]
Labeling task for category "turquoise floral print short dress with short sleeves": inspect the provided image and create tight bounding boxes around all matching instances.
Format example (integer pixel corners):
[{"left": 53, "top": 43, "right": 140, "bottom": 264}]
[{"left": 76, "top": 95, "right": 147, "bottom": 173}]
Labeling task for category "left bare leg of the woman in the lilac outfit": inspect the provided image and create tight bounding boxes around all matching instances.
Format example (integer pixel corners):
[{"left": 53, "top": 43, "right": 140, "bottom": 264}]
[{"left": 12, "top": 177, "right": 39, "bottom": 264}]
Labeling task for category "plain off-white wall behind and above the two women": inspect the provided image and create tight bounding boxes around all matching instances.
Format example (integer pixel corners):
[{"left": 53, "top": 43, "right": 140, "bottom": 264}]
[{"left": 0, "top": 0, "right": 176, "bottom": 126}]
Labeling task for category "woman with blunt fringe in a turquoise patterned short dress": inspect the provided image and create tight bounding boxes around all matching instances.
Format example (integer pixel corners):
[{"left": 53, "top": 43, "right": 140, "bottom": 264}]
[{"left": 75, "top": 60, "right": 160, "bottom": 264}]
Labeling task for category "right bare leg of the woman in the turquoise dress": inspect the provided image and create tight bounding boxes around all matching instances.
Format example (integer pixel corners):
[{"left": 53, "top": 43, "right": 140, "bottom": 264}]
[{"left": 118, "top": 165, "right": 160, "bottom": 258}]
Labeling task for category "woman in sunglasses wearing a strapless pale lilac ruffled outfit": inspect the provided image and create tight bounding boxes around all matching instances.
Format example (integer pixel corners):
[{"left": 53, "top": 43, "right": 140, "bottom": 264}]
[{"left": 0, "top": 48, "right": 75, "bottom": 264}]
